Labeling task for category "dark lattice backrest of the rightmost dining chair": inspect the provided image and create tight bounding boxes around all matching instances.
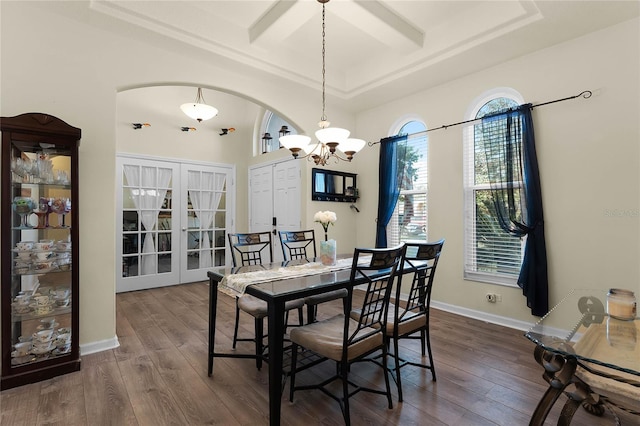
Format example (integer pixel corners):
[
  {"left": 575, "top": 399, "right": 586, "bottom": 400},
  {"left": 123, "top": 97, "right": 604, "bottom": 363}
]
[{"left": 396, "top": 239, "right": 444, "bottom": 324}]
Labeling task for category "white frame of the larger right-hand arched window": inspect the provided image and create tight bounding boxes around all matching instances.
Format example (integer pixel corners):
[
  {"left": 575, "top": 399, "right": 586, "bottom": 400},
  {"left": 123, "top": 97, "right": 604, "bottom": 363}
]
[{"left": 463, "top": 87, "right": 526, "bottom": 287}]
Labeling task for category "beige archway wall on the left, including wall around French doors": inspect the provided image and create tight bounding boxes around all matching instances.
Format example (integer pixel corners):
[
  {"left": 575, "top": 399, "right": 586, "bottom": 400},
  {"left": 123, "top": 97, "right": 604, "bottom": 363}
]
[{"left": 0, "top": 1, "right": 355, "bottom": 350}]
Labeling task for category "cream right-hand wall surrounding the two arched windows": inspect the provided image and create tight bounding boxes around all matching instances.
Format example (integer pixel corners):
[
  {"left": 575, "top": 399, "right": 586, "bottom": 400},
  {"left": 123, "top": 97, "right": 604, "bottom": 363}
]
[{"left": 357, "top": 15, "right": 640, "bottom": 322}]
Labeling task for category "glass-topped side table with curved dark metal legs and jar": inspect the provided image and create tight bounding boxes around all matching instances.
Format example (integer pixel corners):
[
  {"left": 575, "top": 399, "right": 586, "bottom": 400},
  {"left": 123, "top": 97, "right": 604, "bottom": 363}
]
[{"left": 525, "top": 290, "right": 640, "bottom": 425}]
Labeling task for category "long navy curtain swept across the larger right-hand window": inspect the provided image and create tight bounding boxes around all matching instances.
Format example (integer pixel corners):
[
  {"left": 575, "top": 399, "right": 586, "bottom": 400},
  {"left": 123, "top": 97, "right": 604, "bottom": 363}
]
[{"left": 482, "top": 104, "right": 549, "bottom": 316}]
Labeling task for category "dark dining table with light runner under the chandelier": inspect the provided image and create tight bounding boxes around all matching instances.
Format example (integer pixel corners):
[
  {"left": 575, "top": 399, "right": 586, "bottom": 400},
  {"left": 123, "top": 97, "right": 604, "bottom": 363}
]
[{"left": 207, "top": 254, "right": 416, "bottom": 425}]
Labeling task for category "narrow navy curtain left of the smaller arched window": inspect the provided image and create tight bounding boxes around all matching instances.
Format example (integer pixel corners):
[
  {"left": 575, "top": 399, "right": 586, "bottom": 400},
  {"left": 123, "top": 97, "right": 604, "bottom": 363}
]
[{"left": 376, "top": 135, "right": 407, "bottom": 248}]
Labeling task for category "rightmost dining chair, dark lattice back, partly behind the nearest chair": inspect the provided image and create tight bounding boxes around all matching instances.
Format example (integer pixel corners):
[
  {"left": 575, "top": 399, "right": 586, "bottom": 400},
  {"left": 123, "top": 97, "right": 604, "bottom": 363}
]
[{"left": 351, "top": 239, "right": 444, "bottom": 402}]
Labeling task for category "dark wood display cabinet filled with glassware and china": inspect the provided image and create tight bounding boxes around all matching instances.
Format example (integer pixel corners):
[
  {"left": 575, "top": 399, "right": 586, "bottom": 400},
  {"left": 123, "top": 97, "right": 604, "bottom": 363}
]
[{"left": 0, "top": 113, "right": 81, "bottom": 389}]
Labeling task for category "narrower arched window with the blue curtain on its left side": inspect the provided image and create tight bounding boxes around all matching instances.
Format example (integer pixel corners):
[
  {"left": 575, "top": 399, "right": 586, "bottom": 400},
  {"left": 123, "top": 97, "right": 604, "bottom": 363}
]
[{"left": 387, "top": 121, "right": 427, "bottom": 247}]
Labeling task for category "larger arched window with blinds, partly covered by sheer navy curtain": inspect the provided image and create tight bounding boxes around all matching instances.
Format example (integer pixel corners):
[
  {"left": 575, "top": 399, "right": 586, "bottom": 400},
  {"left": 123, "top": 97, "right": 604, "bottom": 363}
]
[{"left": 464, "top": 89, "right": 524, "bottom": 285}]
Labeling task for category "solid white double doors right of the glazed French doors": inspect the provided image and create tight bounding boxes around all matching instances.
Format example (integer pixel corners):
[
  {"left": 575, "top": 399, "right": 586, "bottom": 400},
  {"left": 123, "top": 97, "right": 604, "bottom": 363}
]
[{"left": 249, "top": 160, "right": 302, "bottom": 262}]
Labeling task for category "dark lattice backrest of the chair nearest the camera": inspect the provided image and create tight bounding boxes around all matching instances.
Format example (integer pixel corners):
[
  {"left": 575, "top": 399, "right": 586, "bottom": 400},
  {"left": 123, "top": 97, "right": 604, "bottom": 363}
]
[{"left": 343, "top": 244, "right": 405, "bottom": 352}]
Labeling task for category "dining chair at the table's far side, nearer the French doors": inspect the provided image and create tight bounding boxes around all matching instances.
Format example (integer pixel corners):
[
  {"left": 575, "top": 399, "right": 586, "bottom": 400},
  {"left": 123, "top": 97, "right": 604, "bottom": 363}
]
[{"left": 228, "top": 232, "right": 304, "bottom": 370}]
